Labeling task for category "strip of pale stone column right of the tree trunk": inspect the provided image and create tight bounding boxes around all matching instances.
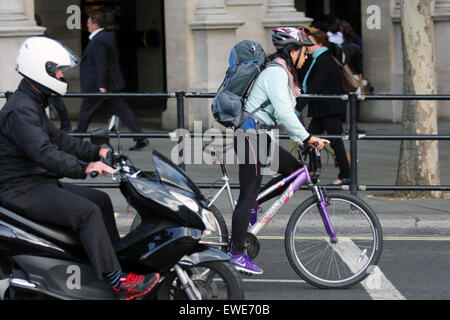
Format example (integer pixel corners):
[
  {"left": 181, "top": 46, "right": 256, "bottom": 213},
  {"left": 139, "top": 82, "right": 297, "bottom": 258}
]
[{"left": 433, "top": 0, "right": 450, "bottom": 120}]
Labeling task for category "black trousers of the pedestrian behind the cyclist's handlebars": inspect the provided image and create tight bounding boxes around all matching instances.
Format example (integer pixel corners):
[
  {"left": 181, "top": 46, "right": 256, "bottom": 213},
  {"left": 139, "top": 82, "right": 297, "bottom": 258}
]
[{"left": 308, "top": 114, "right": 350, "bottom": 179}]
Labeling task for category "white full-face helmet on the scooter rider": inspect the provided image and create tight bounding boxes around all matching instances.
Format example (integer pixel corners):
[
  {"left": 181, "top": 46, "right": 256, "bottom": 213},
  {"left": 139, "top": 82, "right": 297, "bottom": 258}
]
[{"left": 16, "top": 37, "right": 79, "bottom": 95}]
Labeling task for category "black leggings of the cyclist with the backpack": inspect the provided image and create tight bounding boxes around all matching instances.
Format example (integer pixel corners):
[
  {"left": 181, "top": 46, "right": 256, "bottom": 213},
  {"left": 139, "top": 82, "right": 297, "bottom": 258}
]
[{"left": 231, "top": 133, "right": 302, "bottom": 254}]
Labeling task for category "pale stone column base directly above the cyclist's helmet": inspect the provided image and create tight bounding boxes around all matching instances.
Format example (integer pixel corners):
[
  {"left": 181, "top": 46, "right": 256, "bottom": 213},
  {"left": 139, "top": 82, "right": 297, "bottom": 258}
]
[{"left": 262, "top": 0, "right": 313, "bottom": 52}]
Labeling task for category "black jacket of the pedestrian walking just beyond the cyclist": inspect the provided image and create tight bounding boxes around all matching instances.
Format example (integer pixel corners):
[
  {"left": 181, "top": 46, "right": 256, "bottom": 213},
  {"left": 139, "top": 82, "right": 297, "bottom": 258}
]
[{"left": 296, "top": 51, "right": 345, "bottom": 118}]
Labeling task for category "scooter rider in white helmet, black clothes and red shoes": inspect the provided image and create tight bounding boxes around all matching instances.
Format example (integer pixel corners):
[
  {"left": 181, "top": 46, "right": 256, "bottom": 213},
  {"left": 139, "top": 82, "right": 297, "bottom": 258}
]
[{"left": 0, "top": 37, "right": 159, "bottom": 300}]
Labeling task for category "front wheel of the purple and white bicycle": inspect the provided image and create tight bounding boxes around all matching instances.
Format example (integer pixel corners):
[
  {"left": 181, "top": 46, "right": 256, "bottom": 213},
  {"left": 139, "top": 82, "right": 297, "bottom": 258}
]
[{"left": 285, "top": 193, "right": 383, "bottom": 288}]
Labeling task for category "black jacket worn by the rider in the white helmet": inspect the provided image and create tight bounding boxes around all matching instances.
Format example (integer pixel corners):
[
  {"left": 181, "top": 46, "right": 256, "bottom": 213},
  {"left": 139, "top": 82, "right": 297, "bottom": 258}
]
[{"left": 0, "top": 80, "right": 100, "bottom": 195}]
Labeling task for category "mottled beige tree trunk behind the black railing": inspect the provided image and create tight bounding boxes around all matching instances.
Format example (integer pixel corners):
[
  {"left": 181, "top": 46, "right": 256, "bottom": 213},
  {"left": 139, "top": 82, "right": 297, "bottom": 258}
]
[{"left": 396, "top": 0, "right": 442, "bottom": 198}]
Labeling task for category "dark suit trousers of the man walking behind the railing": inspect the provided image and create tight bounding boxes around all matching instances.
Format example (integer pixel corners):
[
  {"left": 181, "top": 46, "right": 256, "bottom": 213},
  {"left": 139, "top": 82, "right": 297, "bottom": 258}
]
[{"left": 74, "top": 98, "right": 142, "bottom": 141}]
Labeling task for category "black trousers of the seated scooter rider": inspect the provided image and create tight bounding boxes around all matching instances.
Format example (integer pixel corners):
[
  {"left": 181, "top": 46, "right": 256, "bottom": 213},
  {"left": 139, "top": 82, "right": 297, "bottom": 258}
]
[{"left": 4, "top": 180, "right": 121, "bottom": 279}]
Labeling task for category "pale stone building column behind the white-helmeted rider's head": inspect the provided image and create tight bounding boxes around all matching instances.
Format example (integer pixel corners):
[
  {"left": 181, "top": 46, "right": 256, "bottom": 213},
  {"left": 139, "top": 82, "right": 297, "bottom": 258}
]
[{"left": 0, "top": 0, "right": 45, "bottom": 108}]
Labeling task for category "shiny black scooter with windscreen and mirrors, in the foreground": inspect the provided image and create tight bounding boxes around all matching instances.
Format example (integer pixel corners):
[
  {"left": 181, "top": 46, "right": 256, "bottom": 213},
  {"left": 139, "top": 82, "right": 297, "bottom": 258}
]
[{"left": 0, "top": 117, "right": 244, "bottom": 300}]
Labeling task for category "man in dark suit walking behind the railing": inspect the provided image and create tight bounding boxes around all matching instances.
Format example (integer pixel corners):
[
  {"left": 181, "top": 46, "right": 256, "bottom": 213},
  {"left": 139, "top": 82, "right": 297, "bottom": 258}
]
[{"left": 74, "top": 11, "right": 150, "bottom": 150}]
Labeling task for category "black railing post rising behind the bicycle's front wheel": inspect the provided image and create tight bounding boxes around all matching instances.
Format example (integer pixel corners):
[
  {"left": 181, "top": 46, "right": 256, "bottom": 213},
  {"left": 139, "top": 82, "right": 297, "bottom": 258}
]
[{"left": 349, "top": 93, "right": 358, "bottom": 196}]
